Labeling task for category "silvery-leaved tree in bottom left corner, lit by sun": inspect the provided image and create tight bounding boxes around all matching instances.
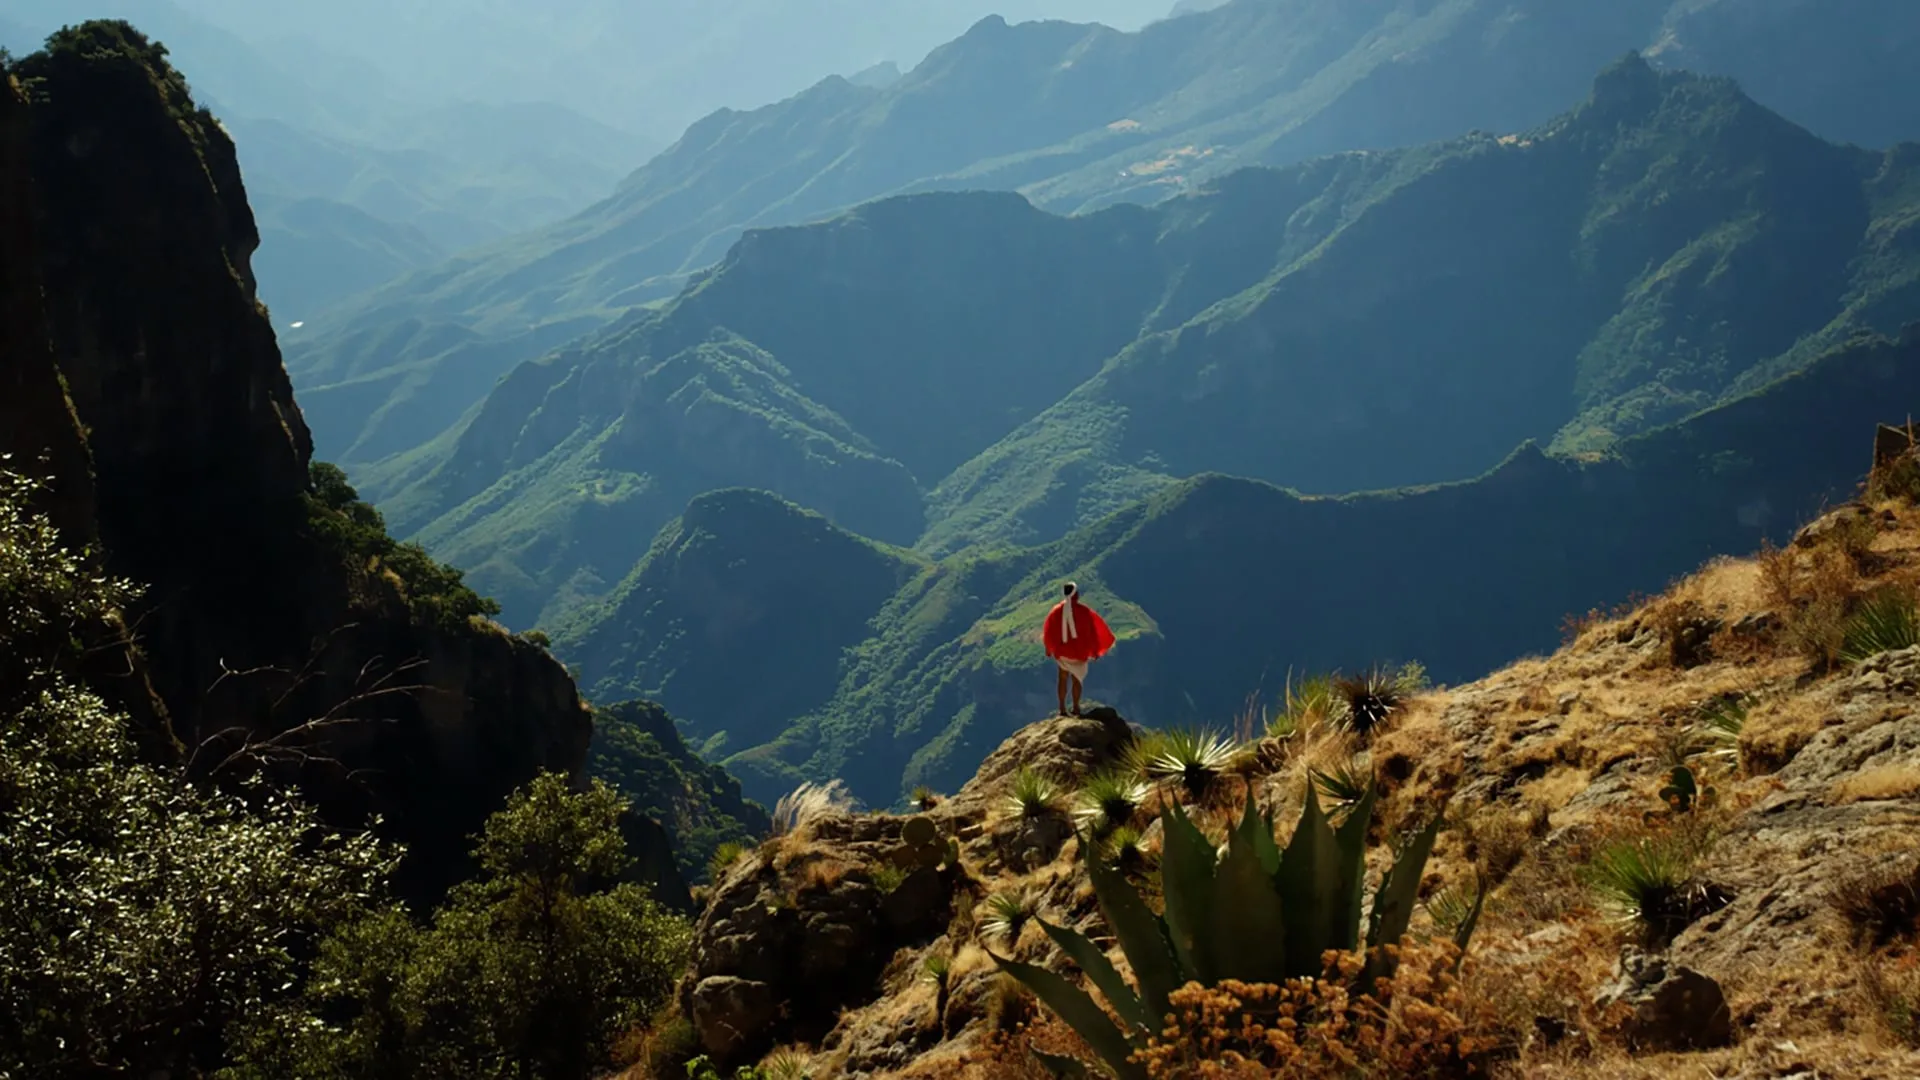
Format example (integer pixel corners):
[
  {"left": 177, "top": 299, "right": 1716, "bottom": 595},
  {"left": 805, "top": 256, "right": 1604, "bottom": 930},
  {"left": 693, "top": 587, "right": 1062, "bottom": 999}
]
[{"left": 0, "top": 471, "right": 390, "bottom": 1076}]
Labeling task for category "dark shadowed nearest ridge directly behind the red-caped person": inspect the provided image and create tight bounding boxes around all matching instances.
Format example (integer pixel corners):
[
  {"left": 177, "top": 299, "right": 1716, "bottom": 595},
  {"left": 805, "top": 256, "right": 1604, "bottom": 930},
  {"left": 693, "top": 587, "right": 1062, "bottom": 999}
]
[{"left": 563, "top": 329, "right": 1920, "bottom": 805}]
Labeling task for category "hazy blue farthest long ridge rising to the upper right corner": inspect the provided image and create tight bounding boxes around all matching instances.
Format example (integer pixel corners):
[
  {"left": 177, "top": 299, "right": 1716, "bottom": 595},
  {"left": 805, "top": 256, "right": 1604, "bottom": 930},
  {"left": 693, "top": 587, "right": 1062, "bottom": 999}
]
[{"left": 290, "top": 0, "right": 1920, "bottom": 465}]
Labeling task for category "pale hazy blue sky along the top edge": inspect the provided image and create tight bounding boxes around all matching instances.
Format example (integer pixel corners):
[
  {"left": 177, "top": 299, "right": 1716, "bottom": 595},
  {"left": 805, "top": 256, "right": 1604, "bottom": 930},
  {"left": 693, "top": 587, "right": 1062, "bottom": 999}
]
[{"left": 8, "top": 0, "right": 1173, "bottom": 142}]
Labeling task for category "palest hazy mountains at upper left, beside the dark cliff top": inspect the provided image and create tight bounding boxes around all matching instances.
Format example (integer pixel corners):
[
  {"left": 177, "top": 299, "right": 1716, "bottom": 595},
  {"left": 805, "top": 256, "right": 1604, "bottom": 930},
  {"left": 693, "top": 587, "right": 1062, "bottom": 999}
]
[{"left": 0, "top": 0, "right": 657, "bottom": 319}]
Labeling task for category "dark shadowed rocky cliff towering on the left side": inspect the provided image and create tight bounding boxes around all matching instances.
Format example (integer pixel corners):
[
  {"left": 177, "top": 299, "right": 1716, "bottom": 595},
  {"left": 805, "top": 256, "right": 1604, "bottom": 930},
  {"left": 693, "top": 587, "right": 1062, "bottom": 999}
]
[{"left": 0, "top": 23, "right": 591, "bottom": 896}]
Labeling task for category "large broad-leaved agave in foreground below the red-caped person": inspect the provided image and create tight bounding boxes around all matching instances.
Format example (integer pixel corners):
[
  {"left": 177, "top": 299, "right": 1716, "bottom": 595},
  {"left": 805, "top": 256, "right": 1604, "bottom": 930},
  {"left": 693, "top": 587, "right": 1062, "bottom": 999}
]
[{"left": 995, "top": 788, "right": 1440, "bottom": 1080}]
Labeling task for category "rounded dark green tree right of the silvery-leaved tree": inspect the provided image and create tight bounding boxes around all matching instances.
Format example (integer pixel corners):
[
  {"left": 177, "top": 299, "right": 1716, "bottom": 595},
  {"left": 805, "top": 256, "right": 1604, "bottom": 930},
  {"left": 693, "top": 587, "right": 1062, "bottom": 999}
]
[{"left": 234, "top": 773, "right": 691, "bottom": 1080}]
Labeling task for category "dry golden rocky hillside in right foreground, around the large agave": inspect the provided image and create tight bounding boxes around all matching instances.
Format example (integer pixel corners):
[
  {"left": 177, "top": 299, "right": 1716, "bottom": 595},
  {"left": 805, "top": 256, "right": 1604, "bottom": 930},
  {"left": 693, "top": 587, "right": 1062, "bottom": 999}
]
[{"left": 634, "top": 429, "right": 1920, "bottom": 1080}]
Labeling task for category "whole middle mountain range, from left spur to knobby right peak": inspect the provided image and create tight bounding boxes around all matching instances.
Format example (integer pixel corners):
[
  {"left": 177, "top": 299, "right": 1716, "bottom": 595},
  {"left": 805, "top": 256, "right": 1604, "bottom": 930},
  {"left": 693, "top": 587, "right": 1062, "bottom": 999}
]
[{"left": 385, "top": 60, "right": 1920, "bottom": 625}]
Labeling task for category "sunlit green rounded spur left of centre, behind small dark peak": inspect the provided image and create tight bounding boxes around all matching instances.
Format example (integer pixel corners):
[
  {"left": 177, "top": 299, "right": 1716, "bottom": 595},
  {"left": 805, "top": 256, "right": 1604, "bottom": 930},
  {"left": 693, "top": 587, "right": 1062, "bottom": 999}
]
[{"left": 388, "top": 323, "right": 924, "bottom": 625}]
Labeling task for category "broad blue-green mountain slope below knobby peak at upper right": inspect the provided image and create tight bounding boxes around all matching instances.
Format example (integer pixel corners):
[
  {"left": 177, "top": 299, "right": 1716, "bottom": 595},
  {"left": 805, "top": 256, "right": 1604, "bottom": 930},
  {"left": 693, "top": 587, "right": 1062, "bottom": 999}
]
[{"left": 921, "top": 60, "right": 1920, "bottom": 553}]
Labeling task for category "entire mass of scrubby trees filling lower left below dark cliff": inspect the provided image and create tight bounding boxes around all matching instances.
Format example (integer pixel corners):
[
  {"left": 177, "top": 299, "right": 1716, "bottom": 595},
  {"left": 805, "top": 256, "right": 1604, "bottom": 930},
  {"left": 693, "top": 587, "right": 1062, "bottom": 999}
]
[{"left": 0, "top": 473, "right": 687, "bottom": 1080}]
